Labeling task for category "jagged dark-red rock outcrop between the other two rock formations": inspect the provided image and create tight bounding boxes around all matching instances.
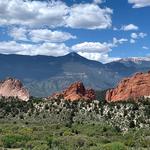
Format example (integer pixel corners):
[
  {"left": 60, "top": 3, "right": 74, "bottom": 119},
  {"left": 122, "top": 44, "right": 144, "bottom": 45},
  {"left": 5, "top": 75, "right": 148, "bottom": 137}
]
[{"left": 49, "top": 82, "right": 96, "bottom": 101}]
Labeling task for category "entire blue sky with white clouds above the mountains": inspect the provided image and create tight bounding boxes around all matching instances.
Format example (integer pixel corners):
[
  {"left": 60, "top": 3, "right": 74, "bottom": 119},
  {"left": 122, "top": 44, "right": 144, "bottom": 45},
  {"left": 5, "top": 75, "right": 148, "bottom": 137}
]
[{"left": 0, "top": 0, "right": 150, "bottom": 63}]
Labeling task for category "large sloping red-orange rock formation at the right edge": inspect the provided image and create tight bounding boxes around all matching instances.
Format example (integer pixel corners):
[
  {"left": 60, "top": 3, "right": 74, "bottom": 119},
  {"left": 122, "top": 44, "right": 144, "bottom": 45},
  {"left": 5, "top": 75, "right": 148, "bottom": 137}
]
[{"left": 106, "top": 72, "right": 150, "bottom": 102}]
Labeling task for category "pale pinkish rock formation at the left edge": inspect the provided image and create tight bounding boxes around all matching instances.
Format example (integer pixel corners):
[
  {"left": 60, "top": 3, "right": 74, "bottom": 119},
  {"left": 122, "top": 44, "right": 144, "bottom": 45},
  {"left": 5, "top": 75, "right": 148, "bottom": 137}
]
[{"left": 0, "top": 78, "right": 29, "bottom": 101}]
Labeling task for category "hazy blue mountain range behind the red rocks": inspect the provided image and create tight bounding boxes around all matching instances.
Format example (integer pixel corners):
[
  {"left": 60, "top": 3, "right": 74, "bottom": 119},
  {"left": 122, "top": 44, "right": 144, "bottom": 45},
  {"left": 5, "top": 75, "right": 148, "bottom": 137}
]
[{"left": 0, "top": 52, "right": 150, "bottom": 97}]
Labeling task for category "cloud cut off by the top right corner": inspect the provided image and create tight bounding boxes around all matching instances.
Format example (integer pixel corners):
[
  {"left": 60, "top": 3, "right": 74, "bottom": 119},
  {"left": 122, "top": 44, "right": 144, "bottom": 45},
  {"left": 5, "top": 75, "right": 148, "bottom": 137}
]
[{"left": 128, "top": 0, "right": 150, "bottom": 8}]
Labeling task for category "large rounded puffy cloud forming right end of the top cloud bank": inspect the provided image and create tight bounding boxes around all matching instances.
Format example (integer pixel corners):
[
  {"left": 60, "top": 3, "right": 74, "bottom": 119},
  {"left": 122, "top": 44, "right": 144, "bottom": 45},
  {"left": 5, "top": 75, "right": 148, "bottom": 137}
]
[{"left": 66, "top": 4, "right": 113, "bottom": 29}]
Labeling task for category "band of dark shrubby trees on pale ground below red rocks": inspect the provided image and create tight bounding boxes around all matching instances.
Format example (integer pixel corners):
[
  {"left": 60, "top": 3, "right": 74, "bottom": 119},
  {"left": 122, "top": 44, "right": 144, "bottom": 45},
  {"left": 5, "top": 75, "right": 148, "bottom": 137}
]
[{"left": 0, "top": 95, "right": 150, "bottom": 130}]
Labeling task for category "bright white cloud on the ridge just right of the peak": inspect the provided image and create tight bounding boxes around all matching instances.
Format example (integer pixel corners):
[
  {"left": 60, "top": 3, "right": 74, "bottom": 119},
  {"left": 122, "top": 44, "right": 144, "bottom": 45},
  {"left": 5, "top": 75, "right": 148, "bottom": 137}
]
[{"left": 71, "top": 38, "right": 128, "bottom": 63}]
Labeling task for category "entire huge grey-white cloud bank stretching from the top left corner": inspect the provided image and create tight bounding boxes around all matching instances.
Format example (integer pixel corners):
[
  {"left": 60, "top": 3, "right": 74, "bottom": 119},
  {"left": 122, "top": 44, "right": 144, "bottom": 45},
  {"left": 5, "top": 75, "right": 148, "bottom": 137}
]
[{"left": 0, "top": 0, "right": 113, "bottom": 29}]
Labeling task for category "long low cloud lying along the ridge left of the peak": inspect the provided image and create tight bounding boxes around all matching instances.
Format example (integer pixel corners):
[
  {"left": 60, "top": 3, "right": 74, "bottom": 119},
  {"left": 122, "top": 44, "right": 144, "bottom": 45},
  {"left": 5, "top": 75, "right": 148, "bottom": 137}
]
[{"left": 0, "top": 41, "right": 69, "bottom": 56}]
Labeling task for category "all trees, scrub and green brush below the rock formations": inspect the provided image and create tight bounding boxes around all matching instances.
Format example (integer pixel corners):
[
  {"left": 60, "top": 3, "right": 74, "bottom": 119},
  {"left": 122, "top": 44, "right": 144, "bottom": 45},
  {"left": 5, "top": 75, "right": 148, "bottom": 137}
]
[{"left": 0, "top": 95, "right": 150, "bottom": 150}]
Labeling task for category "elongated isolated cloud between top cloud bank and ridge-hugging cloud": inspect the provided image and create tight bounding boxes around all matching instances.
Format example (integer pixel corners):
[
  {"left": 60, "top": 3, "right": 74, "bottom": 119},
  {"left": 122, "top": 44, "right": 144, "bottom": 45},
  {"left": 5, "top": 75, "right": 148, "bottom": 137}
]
[{"left": 10, "top": 28, "right": 76, "bottom": 43}]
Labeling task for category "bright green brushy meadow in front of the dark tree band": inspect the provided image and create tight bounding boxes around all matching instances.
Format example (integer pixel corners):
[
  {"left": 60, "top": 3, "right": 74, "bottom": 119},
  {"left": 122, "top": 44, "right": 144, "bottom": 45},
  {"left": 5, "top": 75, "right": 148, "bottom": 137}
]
[{"left": 0, "top": 120, "right": 150, "bottom": 150}]
